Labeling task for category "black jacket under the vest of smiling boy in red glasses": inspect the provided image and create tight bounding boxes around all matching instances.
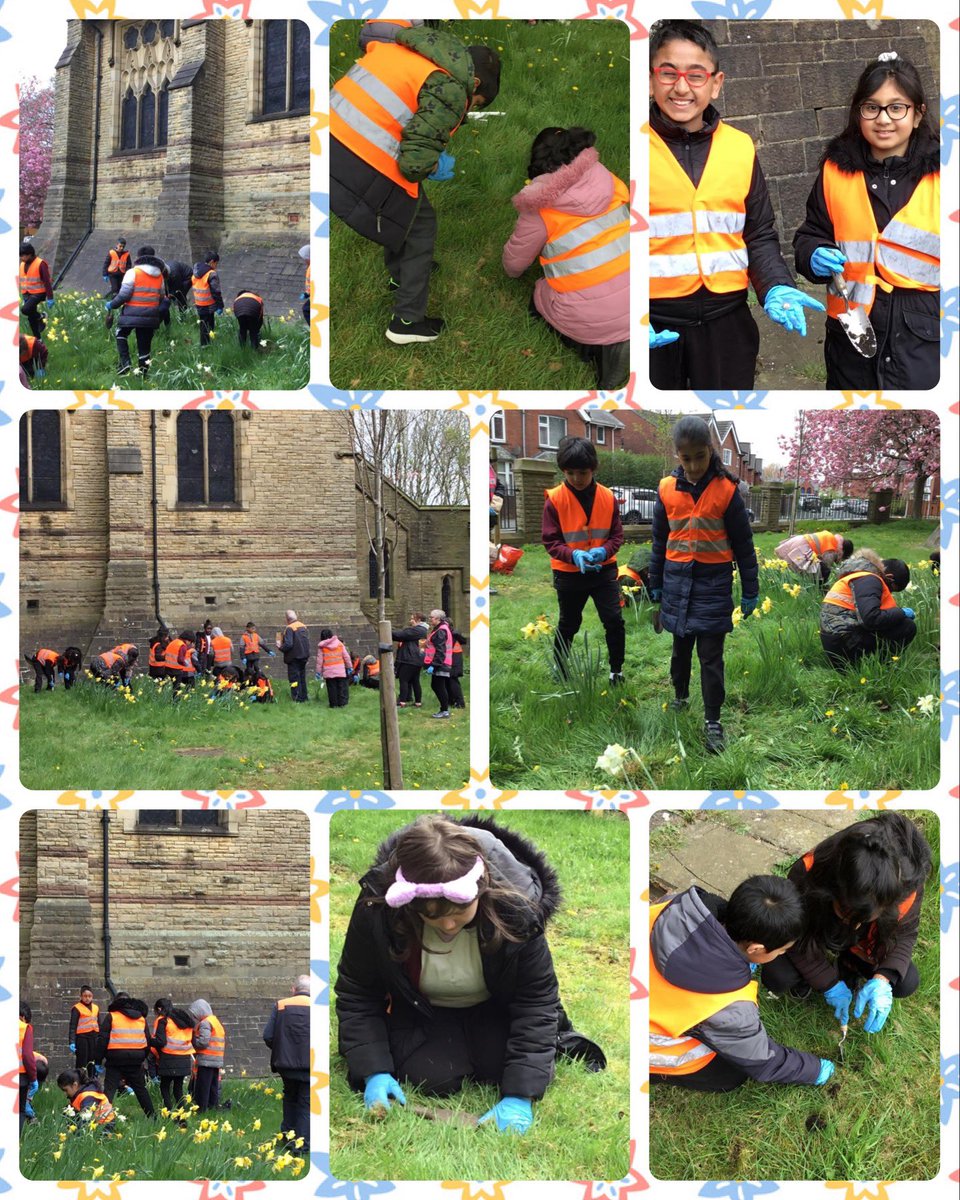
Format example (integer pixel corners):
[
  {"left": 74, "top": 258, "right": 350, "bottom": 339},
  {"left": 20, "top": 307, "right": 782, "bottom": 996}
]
[{"left": 650, "top": 104, "right": 793, "bottom": 328}]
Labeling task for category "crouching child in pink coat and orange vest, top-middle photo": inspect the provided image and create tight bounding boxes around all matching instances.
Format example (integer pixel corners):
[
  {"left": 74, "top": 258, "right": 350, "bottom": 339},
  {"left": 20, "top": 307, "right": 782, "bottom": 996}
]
[{"left": 503, "top": 126, "right": 630, "bottom": 391}]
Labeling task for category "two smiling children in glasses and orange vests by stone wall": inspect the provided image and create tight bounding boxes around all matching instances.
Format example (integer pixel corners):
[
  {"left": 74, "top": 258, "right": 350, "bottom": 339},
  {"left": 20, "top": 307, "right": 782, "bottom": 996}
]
[{"left": 649, "top": 19, "right": 940, "bottom": 391}]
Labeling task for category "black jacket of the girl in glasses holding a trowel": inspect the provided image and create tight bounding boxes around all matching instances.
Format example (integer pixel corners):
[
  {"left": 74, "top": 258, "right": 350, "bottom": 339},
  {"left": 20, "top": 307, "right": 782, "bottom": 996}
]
[{"left": 793, "top": 134, "right": 940, "bottom": 390}]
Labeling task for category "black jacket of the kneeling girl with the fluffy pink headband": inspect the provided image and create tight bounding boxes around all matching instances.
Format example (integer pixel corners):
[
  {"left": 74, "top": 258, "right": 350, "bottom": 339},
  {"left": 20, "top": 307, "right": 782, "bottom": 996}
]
[{"left": 334, "top": 816, "right": 563, "bottom": 1099}]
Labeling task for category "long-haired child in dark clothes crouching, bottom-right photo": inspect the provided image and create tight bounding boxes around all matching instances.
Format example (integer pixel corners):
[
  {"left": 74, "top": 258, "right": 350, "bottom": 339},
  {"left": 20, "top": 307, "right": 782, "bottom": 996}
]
[{"left": 763, "top": 812, "right": 931, "bottom": 1033}]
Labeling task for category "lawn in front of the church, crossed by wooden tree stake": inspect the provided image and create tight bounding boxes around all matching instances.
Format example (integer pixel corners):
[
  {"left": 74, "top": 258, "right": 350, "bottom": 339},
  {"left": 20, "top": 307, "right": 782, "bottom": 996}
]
[{"left": 20, "top": 672, "right": 470, "bottom": 791}]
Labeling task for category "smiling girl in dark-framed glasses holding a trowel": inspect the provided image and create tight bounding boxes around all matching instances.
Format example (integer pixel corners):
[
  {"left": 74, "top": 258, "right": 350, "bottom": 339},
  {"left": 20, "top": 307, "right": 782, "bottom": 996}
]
[{"left": 793, "top": 50, "right": 940, "bottom": 391}]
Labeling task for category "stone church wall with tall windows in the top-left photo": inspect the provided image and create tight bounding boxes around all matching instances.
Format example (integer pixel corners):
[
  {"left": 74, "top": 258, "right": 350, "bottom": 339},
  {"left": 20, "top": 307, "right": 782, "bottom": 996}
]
[{"left": 34, "top": 19, "right": 310, "bottom": 302}]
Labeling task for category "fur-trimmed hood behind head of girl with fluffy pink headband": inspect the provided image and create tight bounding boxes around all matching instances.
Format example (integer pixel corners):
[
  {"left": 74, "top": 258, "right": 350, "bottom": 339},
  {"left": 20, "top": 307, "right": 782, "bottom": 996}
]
[{"left": 360, "top": 815, "right": 563, "bottom": 924}]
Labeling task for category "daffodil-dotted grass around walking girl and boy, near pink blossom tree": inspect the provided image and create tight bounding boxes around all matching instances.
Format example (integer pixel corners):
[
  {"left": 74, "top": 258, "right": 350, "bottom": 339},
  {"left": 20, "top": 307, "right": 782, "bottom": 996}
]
[{"left": 490, "top": 521, "right": 940, "bottom": 791}]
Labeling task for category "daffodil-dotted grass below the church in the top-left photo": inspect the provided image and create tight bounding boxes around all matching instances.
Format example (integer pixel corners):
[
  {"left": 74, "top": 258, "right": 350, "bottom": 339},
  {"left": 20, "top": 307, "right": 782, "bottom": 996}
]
[{"left": 20, "top": 284, "right": 310, "bottom": 391}]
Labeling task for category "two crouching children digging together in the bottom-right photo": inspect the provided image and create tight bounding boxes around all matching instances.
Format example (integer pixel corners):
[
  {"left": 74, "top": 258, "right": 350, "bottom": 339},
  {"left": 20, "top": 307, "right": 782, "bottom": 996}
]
[{"left": 649, "top": 812, "right": 931, "bottom": 1092}]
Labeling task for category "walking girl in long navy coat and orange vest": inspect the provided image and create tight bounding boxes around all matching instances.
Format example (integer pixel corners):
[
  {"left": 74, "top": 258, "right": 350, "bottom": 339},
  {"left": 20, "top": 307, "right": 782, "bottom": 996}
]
[{"left": 649, "top": 416, "right": 760, "bottom": 754}]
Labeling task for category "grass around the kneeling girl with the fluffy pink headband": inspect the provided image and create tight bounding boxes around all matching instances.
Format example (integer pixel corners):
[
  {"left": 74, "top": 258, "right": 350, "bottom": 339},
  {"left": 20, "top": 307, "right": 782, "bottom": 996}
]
[{"left": 330, "top": 811, "right": 630, "bottom": 1180}]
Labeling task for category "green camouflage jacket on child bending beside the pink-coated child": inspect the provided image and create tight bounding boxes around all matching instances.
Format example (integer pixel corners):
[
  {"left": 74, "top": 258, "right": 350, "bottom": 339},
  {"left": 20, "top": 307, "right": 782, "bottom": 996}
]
[{"left": 396, "top": 28, "right": 474, "bottom": 182}]
